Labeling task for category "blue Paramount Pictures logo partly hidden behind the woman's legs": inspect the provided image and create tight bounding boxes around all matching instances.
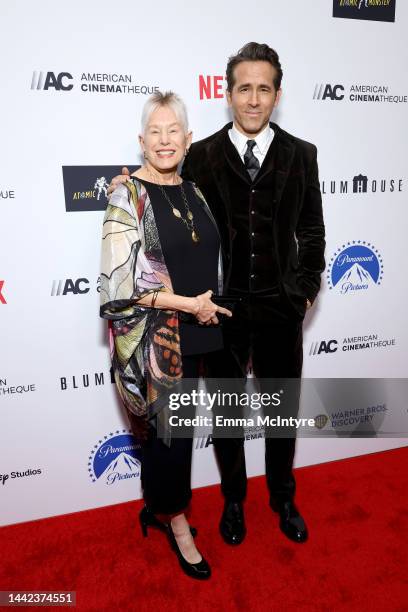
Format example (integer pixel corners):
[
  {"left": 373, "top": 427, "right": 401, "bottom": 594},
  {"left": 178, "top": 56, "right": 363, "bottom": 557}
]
[{"left": 88, "top": 429, "right": 141, "bottom": 485}]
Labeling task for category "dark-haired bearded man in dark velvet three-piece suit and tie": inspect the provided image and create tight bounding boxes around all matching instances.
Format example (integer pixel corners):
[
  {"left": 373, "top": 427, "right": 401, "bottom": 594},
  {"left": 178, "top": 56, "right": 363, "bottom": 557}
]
[{"left": 183, "top": 43, "right": 325, "bottom": 544}]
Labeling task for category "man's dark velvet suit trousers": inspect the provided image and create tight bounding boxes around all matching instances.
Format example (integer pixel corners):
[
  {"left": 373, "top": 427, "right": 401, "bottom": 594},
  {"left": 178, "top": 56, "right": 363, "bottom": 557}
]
[{"left": 207, "top": 296, "right": 303, "bottom": 503}]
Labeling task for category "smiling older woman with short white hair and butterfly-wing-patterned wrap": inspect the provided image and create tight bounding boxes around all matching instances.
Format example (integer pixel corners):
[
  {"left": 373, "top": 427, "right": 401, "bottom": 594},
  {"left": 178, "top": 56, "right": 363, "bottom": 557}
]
[{"left": 100, "top": 92, "right": 231, "bottom": 579}]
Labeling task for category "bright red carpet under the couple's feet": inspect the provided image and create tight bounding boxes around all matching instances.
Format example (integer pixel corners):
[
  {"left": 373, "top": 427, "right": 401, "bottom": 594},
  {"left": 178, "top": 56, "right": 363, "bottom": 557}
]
[{"left": 0, "top": 448, "right": 408, "bottom": 612}]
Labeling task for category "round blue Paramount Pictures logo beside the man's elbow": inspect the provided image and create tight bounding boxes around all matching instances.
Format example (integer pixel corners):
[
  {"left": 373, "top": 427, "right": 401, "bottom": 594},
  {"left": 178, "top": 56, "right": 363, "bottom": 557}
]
[{"left": 327, "top": 240, "right": 384, "bottom": 295}]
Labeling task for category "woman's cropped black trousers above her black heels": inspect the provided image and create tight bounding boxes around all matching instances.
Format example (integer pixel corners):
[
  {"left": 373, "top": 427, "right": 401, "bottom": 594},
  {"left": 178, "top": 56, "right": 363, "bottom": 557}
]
[{"left": 141, "top": 355, "right": 201, "bottom": 515}]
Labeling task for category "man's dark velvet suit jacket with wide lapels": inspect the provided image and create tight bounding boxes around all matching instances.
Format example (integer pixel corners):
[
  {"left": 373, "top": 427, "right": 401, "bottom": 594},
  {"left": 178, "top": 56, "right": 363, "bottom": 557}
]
[{"left": 182, "top": 123, "right": 325, "bottom": 316}]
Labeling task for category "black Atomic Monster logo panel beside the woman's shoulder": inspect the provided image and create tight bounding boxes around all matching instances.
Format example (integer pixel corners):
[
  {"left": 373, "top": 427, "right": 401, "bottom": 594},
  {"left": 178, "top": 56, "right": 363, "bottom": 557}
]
[{"left": 62, "top": 164, "right": 130, "bottom": 212}]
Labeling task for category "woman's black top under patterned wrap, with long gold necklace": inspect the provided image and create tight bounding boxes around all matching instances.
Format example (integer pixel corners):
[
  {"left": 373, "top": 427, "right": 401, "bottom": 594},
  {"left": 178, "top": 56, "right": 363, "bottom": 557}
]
[{"left": 137, "top": 178, "right": 222, "bottom": 355}]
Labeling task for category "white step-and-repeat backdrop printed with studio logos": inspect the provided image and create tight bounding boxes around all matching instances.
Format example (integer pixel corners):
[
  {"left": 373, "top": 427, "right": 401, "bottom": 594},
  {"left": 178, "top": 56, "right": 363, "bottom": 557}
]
[{"left": 0, "top": 0, "right": 408, "bottom": 525}]
